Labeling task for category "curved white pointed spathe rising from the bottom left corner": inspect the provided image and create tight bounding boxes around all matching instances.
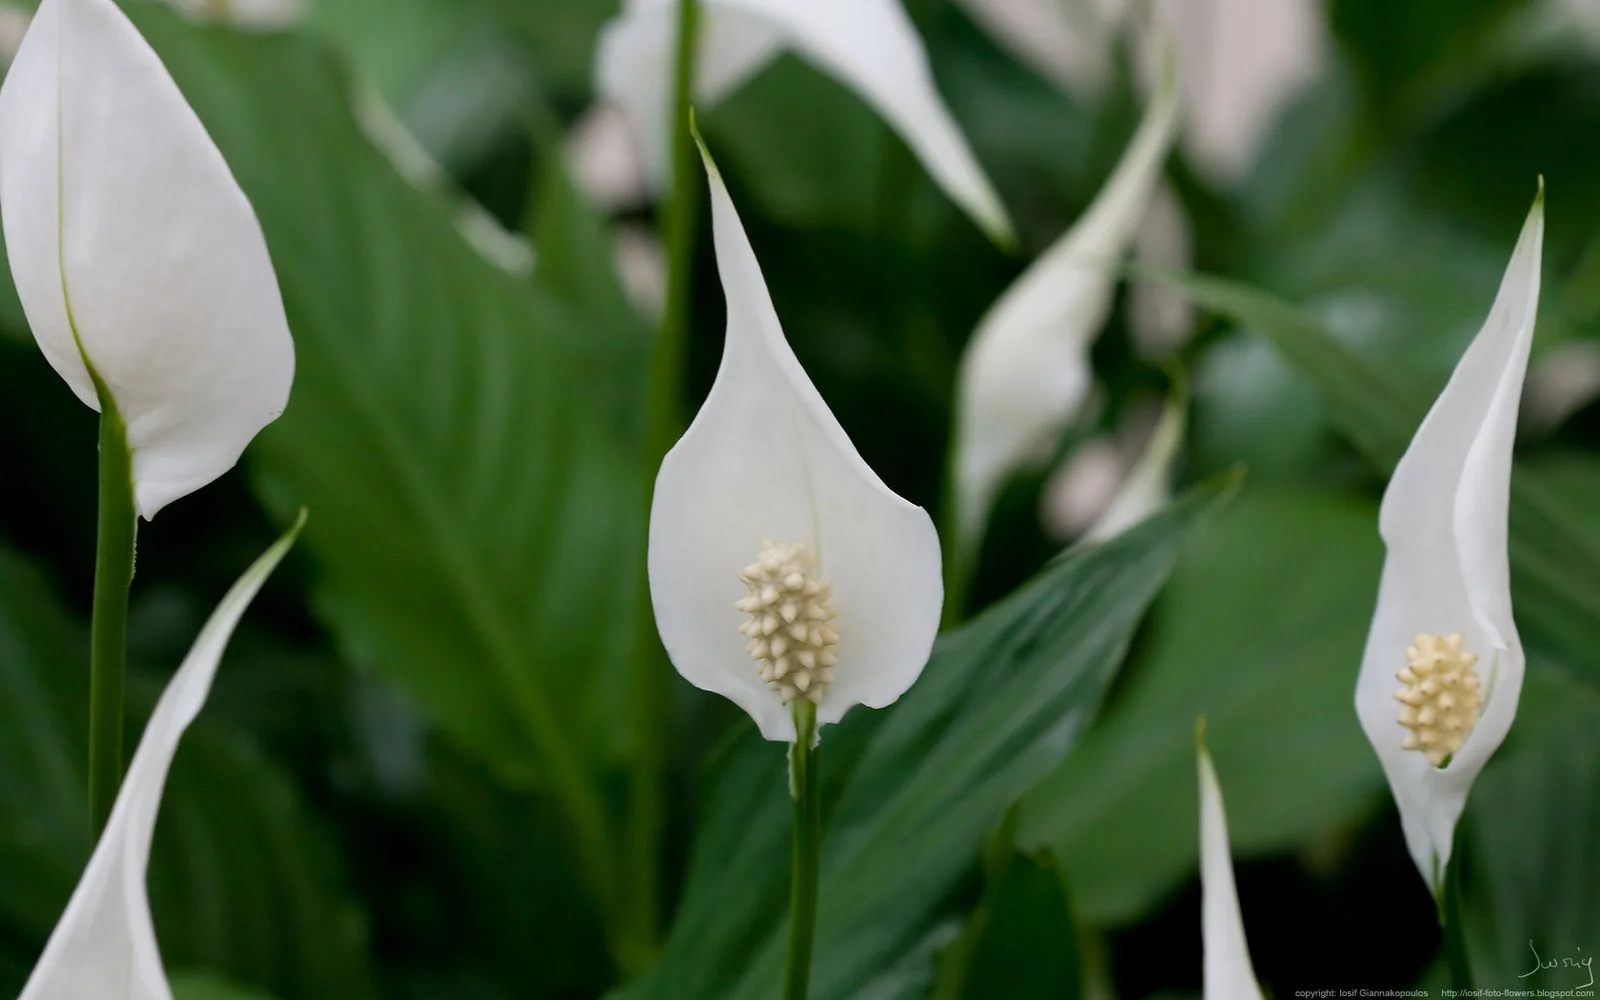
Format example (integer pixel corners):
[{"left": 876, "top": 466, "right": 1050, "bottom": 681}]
[{"left": 19, "top": 514, "right": 306, "bottom": 1000}]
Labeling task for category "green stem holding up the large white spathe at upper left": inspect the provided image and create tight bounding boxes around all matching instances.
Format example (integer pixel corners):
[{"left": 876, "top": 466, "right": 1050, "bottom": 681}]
[{"left": 90, "top": 385, "right": 139, "bottom": 840}]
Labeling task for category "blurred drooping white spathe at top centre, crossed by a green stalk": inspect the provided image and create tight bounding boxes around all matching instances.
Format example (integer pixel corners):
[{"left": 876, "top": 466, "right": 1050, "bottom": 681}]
[{"left": 595, "top": 0, "right": 1011, "bottom": 242}]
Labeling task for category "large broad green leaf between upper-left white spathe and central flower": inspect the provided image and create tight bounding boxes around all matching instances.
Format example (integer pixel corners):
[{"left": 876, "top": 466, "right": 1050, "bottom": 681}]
[{"left": 123, "top": 8, "right": 645, "bottom": 844}]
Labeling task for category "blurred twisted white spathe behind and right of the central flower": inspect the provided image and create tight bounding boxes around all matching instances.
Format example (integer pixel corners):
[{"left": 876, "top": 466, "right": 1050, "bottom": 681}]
[{"left": 955, "top": 44, "right": 1179, "bottom": 547}]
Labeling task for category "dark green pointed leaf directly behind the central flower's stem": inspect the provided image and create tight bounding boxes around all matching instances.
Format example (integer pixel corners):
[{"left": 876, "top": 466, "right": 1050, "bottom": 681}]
[{"left": 622, "top": 476, "right": 1229, "bottom": 1000}]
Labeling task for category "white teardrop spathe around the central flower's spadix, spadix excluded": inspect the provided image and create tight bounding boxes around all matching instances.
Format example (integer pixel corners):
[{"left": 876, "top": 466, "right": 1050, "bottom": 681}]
[{"left": 648, "top": 134, "right": 944, "bottom": 742}]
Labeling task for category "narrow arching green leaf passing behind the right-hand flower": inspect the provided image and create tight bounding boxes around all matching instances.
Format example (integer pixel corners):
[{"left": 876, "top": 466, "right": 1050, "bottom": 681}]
[{"left": 1134, "top": 269, "right": 1600, "bottom": 683}]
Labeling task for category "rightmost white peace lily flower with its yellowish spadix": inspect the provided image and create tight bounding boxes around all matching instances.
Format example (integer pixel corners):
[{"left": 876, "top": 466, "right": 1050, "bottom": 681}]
[{"left": 1355, "top": 191, "right": 1544, "bottom": 896}]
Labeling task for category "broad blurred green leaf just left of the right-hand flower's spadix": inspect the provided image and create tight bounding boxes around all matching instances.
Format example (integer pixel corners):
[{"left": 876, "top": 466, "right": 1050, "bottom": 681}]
[{"left": 1018, "top": 493, "right": 1382, "bottom": 925}]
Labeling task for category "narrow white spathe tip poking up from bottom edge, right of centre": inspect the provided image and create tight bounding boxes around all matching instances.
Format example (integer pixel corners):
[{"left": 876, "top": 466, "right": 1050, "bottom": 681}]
[{"left": 1195, "top": 736, "right": 1262, "bottom": 1000}]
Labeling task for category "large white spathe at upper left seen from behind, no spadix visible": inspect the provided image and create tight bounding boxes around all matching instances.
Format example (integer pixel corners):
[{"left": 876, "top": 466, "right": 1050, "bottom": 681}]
[{"left": 0, "top": 0, "right": 294, "bottom": 518}]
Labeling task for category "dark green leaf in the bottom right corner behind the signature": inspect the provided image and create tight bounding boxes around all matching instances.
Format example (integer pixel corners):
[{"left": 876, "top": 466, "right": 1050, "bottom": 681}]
[{"left": 1456, "top": 669, "right": 1600, "bottom": 990}]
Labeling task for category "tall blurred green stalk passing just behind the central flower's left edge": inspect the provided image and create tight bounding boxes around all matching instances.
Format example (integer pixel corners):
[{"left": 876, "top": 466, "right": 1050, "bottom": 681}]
[{"left": 619, "top": 0, "right": 701, "bottom": 971}]
